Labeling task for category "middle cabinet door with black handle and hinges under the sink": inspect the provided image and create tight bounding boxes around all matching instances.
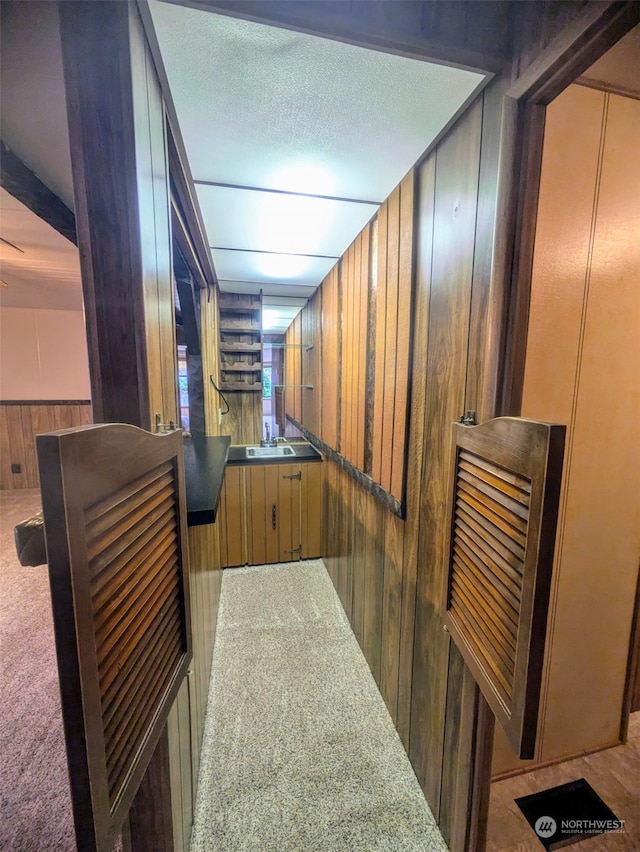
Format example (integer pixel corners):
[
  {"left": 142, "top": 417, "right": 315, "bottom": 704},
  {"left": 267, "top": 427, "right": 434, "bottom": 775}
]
[{"left": 246, "top": 464, "right": 301, "bottom": 565}]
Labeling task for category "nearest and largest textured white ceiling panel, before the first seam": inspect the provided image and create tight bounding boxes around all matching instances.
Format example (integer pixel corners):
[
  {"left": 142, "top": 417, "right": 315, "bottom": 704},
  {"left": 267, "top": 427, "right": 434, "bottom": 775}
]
[{"left": 150, "top": 0, "right": 483, "bottom": 202}]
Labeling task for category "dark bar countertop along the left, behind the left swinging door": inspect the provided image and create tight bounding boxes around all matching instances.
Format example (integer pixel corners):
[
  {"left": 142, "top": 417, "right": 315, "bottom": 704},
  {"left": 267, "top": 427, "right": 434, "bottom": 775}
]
[{"left": 183, "top": 435, "right": 231, "bottom": 527}]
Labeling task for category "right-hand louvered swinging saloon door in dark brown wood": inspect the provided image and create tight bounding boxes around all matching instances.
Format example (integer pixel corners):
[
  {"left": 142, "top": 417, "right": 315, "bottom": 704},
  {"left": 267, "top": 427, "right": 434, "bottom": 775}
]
[{"left": 444, "top": 417, "right": 565, "bottom": 758}]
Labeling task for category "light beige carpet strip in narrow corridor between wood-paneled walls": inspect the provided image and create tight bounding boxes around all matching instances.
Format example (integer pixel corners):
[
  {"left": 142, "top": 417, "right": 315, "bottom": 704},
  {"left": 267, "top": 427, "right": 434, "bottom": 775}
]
[{"left": 191, "top": 560, "right": 446, "bottom": 852}]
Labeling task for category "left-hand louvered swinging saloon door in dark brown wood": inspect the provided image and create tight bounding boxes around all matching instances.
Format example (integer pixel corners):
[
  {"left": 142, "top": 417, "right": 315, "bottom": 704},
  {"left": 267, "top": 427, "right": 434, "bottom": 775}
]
[{"left": 37, "top": 424, "right": 191, "bottom": 852}]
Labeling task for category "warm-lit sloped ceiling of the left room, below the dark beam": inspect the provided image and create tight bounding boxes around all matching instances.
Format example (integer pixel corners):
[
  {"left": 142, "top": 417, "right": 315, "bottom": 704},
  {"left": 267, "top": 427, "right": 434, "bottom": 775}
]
[{"left": 0, "top": 189, "right": 82, "bottom": 310}]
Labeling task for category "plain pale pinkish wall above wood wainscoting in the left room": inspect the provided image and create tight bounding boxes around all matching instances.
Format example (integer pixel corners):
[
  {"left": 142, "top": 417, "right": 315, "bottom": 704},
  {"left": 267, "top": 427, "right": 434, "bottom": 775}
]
[{"left": 0, "top": 307, "right": 90, "bottom": 400}]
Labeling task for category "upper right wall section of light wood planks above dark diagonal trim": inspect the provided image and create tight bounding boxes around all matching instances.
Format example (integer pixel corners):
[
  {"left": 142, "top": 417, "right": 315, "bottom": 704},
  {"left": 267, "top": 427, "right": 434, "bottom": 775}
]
[{"left": 285, "top": 189, "right": 415, "bottom": 503}]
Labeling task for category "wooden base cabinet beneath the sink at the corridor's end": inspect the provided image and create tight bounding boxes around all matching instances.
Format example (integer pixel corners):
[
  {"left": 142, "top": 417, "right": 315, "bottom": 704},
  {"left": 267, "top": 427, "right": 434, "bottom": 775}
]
[{"left": 218, "top": 462, "right": 322, "bottom": 567}]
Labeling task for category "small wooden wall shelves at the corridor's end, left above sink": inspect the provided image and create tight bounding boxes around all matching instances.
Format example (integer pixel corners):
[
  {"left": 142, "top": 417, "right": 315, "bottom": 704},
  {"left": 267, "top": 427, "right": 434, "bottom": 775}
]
[{"left": 218, "top": 293, "right": 262, "bottom": 392}]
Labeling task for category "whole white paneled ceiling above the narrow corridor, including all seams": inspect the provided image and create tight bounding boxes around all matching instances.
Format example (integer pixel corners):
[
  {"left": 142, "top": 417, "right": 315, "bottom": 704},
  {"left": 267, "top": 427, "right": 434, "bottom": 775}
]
[{"left": 149, "top": 0, "right": 484, "bottom": 302}]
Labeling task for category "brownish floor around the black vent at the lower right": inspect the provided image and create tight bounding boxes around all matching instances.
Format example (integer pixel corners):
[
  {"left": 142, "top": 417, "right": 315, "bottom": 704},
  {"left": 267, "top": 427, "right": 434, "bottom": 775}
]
[{"left": 487, "top": 712, "right": 640, "bottom": 852}]
